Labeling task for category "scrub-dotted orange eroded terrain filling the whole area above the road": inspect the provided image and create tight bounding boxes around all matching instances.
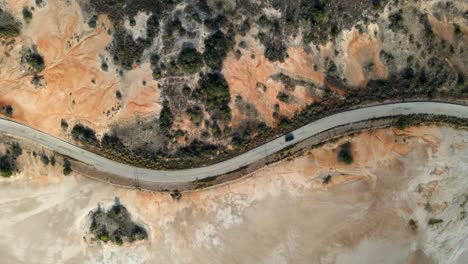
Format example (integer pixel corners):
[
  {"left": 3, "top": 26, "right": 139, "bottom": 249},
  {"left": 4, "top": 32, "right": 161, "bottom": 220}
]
[{"left": 0, "top": 0, "right": 468, "bottom": 168}]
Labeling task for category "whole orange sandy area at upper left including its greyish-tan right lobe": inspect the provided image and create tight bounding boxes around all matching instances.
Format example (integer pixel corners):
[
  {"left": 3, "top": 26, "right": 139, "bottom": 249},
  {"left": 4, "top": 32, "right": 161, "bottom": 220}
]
[{"left": 0, "top": 0, "right": 159, "bottom": 137}]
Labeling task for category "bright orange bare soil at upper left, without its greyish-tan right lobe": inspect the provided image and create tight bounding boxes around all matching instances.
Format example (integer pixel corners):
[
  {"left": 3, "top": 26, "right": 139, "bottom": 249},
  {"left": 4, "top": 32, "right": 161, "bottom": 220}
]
[{"left": 0, "top": 0, "right": 118, "bottom": 136}]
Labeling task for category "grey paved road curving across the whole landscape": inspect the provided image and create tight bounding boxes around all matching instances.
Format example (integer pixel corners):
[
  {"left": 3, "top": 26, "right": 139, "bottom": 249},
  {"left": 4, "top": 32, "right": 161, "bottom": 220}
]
[{"left": 0, "top": 102, "right": 468, "bottom": 183}]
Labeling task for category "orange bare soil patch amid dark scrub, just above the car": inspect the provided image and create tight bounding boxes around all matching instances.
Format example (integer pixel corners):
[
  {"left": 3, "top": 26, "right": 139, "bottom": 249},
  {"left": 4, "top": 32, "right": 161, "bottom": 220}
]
[{"left": 223, "top": 38, "right": 324, "bottom": 126}]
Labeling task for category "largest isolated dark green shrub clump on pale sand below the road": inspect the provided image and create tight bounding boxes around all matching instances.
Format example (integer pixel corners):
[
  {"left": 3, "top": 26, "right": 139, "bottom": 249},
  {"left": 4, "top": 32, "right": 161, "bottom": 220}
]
[{"left": 89, "top": 203, "right": 148, "bottom": 246}]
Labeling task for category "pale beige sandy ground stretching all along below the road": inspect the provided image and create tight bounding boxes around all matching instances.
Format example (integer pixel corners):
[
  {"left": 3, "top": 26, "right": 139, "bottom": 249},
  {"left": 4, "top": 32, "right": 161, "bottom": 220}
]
[{"left": 0, "top": 127, "right": 468, "bottom": 263}]
